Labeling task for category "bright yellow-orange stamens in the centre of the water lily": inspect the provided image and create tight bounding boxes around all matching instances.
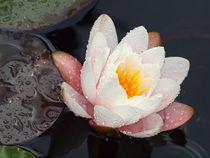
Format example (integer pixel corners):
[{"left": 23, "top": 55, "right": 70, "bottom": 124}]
[{"left": 116, "top": 65, "right": 147, "bottom": 99}]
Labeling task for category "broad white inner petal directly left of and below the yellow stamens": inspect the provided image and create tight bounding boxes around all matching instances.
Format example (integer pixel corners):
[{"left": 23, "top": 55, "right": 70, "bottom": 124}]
[{"left": 96, "top": 71, "right": 127, "bottom": 108}]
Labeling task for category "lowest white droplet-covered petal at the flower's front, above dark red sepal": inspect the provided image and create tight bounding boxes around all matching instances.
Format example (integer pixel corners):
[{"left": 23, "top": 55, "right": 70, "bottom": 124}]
[{"left": 94, "top": 105, "right": 124, "bottom": 128}]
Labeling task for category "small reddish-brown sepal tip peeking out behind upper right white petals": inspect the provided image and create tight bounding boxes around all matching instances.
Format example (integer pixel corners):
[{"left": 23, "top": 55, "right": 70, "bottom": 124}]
[{"left": 148, "top": 32, "right": 162, "bottom": 49}]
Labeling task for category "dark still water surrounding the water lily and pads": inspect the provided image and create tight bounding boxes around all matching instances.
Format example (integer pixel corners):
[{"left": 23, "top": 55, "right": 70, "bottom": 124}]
[{"left": 1, "top": 0, "right": 210, "bottom": 158}]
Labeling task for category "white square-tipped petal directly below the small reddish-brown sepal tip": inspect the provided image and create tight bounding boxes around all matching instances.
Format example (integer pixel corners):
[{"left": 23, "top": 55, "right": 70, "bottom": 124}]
[{"left": 141, "top": 47, "right": 165, "bottom": 67}]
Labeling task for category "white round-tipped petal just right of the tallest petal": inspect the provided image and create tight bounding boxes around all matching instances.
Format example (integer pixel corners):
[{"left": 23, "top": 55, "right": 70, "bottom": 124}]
[{"left": 120, "top": 26, "right": 149, "bottom": 53}]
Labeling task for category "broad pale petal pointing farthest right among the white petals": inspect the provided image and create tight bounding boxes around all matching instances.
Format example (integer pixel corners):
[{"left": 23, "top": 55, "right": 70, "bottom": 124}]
[{"left": 161, "top": 57, "right": 190, "bottom": 84}]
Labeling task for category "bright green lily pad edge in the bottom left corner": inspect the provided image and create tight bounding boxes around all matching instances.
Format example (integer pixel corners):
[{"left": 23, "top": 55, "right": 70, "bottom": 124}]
[{"left": 0, "top": 146, "right": 35, "bottom": 158}]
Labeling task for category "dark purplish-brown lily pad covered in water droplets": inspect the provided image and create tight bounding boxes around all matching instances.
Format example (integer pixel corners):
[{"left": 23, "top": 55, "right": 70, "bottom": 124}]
[{"left": 0, "top": 30, "right": 63, "bottom": 144}]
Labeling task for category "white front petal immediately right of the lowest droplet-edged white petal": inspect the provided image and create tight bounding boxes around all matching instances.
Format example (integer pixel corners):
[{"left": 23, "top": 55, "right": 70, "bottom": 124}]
[{"left": 112, "top": 105, "right": 141, "bottom": 125}]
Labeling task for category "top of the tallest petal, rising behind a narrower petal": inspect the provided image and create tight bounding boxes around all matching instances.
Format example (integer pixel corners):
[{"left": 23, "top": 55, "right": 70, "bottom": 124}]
[{"left": 88, "top": 14, "right": 118, "bottom": 51}]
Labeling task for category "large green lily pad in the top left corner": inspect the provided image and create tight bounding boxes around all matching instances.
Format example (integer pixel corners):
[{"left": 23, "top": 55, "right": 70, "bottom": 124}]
[{"left": 0, "top": 0, "right": 92, "bottom": 30}]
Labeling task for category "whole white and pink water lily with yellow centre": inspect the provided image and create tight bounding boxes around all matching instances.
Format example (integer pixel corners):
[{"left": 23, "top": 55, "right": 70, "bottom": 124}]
[{"left": 53, "top": 15, "right": 193, "bottom": 138}]
